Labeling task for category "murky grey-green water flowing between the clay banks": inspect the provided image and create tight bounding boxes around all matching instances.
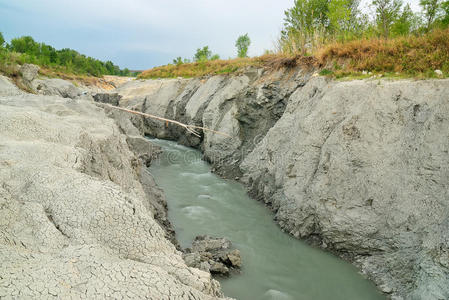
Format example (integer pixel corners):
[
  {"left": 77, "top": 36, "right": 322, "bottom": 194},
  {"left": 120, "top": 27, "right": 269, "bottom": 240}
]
[{"left": 150, "top": 140, "right": 385, "bottom": 300}]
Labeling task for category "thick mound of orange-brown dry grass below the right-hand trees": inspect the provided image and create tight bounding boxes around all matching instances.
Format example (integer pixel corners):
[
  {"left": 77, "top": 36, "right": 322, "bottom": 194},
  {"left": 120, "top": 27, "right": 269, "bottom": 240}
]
[{"left": 316, "top": 29, "right": 449, "bottom": 77}]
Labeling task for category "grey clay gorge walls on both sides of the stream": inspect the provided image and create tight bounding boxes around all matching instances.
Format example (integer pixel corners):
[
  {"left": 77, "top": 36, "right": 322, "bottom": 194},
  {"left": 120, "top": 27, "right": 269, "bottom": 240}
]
[{"left": 0, "top": 64, "right": 449, "bottom": 299}]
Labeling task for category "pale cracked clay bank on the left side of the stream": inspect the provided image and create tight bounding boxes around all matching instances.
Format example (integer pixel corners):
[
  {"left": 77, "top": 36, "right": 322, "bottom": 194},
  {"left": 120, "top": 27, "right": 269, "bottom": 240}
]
[{"left": 0, "top": 76, "right": 222, "bottom": 299}]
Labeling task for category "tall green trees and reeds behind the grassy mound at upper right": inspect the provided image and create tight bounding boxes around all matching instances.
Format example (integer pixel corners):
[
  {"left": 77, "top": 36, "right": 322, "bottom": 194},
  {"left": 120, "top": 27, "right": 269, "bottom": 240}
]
[{"left": 276, "top": 0, "right": 449, "bottom": 54}]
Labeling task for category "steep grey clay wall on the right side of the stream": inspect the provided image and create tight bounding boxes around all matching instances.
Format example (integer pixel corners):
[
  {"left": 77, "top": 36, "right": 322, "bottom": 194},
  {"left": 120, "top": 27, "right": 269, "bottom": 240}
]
[{"left": 117, "top": 69, "right": 449, "bottom": 299}]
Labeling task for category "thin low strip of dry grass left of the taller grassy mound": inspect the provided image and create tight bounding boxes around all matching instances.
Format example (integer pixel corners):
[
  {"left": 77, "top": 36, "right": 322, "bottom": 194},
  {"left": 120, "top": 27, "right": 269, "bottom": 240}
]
[{"left": 138, "top": 54, "right": 317, "bottom": 79}]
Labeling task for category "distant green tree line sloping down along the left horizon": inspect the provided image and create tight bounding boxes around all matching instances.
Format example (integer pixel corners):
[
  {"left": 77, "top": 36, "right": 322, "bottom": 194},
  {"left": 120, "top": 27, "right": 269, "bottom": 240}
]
[{"left": 0, "top": 32, "right": 137, "bottom": 77}]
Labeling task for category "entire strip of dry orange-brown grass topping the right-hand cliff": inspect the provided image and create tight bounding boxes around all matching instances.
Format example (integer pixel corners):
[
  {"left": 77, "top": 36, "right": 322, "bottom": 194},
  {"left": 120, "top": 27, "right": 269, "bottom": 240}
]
[{"left": 138, "top": 29, "right": 449, "bottom": 79}]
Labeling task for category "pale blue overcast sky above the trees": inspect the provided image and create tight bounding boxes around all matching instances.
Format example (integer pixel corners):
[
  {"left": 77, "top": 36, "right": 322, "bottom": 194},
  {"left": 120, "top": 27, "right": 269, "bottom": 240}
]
[{"left": 0, "top": 0, "right": 418, "bottom": 70}]
